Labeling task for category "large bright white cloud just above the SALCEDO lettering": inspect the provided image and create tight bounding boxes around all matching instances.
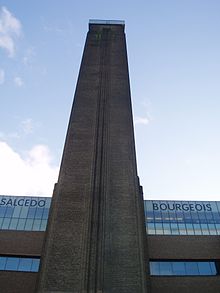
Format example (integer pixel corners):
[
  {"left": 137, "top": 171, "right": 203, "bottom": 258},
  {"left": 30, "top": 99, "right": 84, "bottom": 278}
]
[{"left": 0, "top": 141, "right": 58, "bottom": 196}]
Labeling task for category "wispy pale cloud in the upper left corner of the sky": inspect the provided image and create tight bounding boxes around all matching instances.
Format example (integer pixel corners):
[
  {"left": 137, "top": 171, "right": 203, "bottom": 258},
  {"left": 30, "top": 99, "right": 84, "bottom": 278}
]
[{"left": 0, "top": 7, "right": 21, "bottom": 57}]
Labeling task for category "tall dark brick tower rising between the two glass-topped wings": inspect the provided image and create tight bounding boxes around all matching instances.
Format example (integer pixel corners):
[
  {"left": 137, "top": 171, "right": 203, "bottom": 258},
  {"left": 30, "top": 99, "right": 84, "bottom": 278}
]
[{"left": 36, "top": 21, "right": 147, "bottom": 293}]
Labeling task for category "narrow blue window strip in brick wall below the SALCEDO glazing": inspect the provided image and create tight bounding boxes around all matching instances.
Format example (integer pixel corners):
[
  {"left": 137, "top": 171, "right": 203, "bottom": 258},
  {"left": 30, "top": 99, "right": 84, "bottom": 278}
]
[{"left": 0, "top": 256, "right": 40, "bottom": 272}]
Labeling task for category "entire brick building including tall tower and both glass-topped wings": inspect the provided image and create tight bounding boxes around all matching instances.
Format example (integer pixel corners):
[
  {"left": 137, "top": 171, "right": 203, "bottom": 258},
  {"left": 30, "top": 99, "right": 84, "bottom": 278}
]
[{"left": 0, "top": 21, "right": 220, "bottom": 293}]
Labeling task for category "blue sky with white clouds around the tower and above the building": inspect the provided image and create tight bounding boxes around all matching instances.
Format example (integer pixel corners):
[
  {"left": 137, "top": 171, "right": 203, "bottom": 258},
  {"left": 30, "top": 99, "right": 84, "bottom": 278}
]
[{"left": 0, "top": 0, "right": 220, "bottom": 200}]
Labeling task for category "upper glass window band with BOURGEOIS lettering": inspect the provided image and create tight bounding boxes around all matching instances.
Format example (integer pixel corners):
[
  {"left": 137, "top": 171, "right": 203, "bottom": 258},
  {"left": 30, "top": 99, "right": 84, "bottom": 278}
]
[{"left": 145, "top": 201, "right": 220, "bottom": 235}]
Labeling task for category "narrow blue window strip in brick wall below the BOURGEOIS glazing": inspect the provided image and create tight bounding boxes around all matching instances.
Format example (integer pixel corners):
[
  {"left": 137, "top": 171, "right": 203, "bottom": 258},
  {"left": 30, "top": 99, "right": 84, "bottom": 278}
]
[{"left": 150, "top": 261, "right": 219, "bottom": 276}]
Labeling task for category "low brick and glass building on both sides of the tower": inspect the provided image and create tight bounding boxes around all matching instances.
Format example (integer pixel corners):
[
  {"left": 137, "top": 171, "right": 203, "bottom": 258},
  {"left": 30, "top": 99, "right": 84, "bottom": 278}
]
[{"left": 0, "top": 196, "right": 220, "bottom": 293}]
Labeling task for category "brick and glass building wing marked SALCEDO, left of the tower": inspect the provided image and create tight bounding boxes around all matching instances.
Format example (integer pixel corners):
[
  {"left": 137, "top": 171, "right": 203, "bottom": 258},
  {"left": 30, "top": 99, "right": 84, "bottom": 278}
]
[{"left": 0, "top": 196, "right": 51, "bottom": 293}]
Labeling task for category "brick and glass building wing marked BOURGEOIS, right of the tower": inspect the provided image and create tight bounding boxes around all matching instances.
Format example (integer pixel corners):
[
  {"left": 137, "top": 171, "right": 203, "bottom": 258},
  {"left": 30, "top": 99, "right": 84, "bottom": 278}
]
[{"left": 145, "top": 201, "right": 220, "bottom": 293}]
